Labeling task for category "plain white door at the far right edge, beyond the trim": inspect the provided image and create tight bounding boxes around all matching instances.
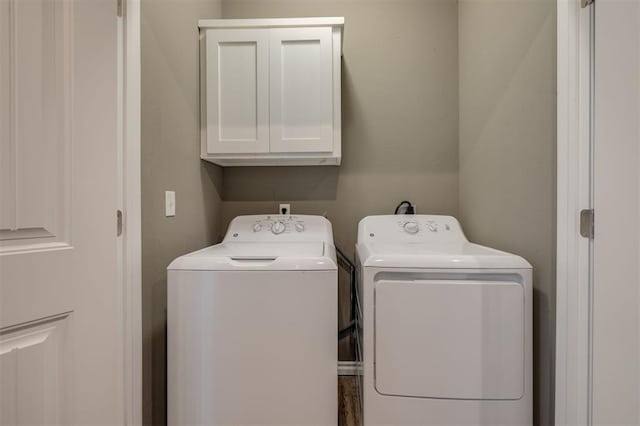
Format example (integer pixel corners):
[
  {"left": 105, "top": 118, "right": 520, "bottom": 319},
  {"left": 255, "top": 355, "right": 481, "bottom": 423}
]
[{"left": 592, "top": 0, "right": 640, "bottom": 425}]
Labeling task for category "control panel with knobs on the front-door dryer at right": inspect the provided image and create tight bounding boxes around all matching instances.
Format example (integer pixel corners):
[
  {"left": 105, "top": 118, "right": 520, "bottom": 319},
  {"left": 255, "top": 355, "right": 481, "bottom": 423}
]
[{"left": 358, "top": 214, "right": 467, "bottom": 242}]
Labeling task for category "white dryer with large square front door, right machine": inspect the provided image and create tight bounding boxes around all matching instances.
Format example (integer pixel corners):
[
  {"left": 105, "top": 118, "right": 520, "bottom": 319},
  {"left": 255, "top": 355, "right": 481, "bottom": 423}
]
[{"left": 356, "top": 215, "right": 532, "bottom": 426}]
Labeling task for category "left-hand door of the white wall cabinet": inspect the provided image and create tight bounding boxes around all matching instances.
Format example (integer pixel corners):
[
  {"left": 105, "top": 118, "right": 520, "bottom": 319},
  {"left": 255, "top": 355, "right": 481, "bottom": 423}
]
[{"left": 204, "top": 29, "right": 269, "bottom": 154}]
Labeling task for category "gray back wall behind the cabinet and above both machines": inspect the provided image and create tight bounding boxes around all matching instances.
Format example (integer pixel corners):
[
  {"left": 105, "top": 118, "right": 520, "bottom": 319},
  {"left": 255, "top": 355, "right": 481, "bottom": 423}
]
[{"left": 222, "top": 0, "right": 458, "bottom": 254}]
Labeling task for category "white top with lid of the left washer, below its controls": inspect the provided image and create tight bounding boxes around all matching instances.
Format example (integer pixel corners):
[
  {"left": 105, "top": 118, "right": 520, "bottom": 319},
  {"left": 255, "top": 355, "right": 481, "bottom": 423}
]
[{"left": 167, "top": 242, "right": 337, "bottom": 271}]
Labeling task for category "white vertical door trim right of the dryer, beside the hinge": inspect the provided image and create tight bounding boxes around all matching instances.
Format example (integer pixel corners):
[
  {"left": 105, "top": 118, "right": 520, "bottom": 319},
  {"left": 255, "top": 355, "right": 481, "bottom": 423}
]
[{"left": 555, "top": 0, "right": 593, "bottom": 426}]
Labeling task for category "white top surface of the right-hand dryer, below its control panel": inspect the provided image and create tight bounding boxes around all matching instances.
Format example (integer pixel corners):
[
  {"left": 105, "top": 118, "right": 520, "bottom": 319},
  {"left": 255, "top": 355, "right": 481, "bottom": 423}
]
[{"left": 357, "top": 241, "right": 531, "bottom": 269}]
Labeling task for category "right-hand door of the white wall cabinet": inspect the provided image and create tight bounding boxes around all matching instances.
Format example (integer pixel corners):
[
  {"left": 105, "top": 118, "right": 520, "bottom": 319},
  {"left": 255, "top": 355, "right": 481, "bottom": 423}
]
[{"left": 270, "top": 27, "right": 333, "bottom": 153}]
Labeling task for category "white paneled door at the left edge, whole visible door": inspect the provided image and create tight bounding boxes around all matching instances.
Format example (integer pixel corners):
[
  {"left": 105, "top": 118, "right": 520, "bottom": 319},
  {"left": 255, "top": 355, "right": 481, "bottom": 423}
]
[{"left": 0, "top": 0, "right": 124, "bottom": 425}]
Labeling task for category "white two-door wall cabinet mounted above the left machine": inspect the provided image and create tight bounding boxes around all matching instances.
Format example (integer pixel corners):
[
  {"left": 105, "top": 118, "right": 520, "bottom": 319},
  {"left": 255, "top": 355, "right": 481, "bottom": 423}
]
[{"left": 199, "top": 18, "right": 344, "bottom": 166}]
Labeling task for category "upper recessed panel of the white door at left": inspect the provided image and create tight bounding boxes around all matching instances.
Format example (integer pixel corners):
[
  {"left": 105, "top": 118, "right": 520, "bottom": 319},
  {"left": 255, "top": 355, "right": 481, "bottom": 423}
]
[{"left": 0, "top": 0, "right": 71, "bottom": 253}]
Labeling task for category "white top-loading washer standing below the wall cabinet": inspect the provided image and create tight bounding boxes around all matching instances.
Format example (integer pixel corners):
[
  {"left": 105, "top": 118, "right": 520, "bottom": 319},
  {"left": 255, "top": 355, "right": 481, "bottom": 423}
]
[{"left": 167, "top": 215, "right": 338, "bottom": 426}]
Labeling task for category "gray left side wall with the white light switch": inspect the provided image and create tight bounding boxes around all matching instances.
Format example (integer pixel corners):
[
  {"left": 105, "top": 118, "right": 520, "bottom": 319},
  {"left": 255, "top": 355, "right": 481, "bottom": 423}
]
[{"left": 141, "top": 0, "right": 222, "bottom": 425}]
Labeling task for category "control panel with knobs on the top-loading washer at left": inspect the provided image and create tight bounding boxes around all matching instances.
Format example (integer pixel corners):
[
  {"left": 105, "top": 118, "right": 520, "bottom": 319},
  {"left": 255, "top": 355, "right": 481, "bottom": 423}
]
[{"left": 224, "top": 215, "right": 333, "bottom": 245}]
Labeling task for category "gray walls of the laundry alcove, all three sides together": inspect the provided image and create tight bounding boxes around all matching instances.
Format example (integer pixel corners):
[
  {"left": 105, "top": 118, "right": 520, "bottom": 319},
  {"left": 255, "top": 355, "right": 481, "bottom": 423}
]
[{"left": 142, "top": 0, "right": 555, "bottom": 425}]
